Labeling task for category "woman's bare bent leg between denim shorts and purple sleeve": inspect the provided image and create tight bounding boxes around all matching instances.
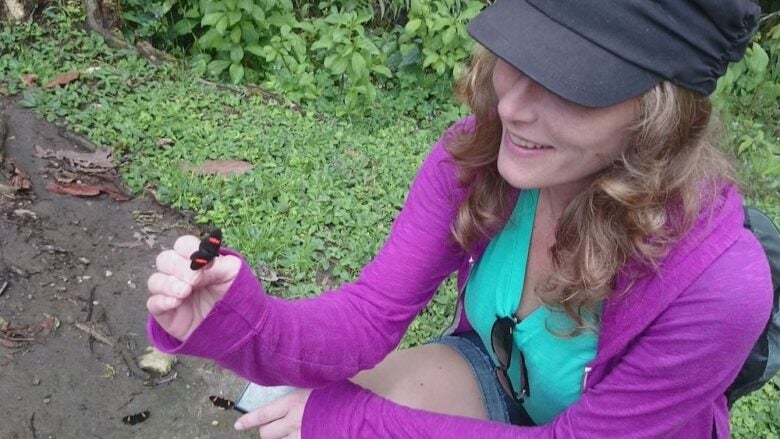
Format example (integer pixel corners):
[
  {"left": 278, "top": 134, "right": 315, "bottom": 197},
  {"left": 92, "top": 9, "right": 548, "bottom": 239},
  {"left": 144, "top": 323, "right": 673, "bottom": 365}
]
[{"left": 351, "top": 344, "right": 487, "bottom": 419}]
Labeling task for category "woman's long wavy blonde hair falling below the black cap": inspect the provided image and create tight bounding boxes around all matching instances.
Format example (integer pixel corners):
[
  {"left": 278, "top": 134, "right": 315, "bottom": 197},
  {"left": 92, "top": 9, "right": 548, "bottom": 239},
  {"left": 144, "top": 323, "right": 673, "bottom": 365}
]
[{"left": 446, "top": 49, "right": 735, "bottom": 335}]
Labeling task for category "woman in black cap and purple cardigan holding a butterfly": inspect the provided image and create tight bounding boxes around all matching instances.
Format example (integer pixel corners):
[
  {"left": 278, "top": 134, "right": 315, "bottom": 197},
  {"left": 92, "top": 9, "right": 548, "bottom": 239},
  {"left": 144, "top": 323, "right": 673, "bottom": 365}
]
[{"left": 147, "top": 0, "right": 771, "bottom": 438}]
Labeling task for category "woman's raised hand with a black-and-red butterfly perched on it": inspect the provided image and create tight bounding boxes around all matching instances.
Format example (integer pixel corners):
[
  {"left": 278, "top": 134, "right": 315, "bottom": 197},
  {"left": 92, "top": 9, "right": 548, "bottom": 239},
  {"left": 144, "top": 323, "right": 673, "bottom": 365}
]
[{"left": 146, "top": 235, "right": 241, "bottom": 342}]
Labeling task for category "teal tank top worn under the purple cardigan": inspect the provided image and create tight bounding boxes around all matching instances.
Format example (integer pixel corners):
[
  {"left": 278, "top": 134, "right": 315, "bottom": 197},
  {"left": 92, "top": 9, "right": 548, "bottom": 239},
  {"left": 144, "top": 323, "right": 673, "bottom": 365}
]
[{"left": 464, "top": 189, "right": 598, "bottom": 425}]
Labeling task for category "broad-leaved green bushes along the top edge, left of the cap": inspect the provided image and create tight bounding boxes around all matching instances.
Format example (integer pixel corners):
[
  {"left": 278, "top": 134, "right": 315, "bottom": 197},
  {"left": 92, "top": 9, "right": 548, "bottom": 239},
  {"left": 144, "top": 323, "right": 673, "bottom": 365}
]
[{"left": 119, "top": 0, "right": 485, "bottom": 110}]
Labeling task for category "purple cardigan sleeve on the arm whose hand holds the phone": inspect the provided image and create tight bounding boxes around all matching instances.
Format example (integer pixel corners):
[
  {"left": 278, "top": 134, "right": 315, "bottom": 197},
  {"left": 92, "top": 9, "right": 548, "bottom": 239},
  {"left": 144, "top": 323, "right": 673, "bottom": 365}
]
[{"left": 303, "top": 232, "right": 772, "bottom": 438}]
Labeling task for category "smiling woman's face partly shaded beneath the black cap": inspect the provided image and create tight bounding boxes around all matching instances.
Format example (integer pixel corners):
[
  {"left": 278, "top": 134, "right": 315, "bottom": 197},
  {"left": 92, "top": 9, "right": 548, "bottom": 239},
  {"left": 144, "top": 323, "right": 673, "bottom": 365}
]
[{"left": 493, "top": 59, "right": 639, "bottom": 196}]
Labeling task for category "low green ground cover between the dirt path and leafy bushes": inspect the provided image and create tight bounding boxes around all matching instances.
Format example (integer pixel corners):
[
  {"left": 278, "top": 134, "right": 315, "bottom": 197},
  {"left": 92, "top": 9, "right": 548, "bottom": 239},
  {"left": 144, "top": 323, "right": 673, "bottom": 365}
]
[{"left": 0, "top": 2, "right": 780, "bottom": 439}]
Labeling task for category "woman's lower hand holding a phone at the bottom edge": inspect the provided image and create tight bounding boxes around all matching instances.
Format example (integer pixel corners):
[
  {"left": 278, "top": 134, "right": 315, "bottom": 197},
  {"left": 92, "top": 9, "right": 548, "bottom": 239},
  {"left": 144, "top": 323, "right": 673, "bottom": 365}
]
[{"left": 234, "top": 389, "right": 311, "bottom": 439}]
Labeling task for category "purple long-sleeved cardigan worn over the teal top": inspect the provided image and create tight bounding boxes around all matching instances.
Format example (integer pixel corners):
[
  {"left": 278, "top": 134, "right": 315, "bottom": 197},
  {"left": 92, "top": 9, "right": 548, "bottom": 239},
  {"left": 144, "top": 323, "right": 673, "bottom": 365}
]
[{"left": 148, "top": 122, "right": 772, "bottom": 439}]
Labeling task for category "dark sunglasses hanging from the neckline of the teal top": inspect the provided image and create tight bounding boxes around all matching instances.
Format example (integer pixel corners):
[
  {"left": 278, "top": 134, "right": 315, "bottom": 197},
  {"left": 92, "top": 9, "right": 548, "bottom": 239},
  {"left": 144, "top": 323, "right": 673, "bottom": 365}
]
[{"left": 490, "top": 317, "right": 531, "bottom": 403}]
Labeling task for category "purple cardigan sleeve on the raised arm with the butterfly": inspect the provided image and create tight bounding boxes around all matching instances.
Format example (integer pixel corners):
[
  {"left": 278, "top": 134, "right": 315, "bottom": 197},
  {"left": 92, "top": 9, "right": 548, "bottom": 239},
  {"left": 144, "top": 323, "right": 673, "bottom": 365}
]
[{"left": 148, "top": 128, "right": 464, "bottom": 387}]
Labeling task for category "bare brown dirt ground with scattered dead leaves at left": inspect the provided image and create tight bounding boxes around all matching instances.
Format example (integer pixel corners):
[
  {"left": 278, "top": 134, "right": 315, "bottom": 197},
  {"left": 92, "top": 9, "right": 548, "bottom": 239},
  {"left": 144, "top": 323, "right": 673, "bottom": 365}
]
[{"left": 0, "top": 98, "right": 256, "bottom": 439}]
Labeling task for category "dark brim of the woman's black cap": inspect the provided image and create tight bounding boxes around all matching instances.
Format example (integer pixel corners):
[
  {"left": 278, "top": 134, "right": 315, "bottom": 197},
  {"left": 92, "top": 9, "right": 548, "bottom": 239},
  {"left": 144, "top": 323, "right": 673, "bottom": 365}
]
[{"left": 468, "top": 0, "right": 661, "bottom": 107}]
